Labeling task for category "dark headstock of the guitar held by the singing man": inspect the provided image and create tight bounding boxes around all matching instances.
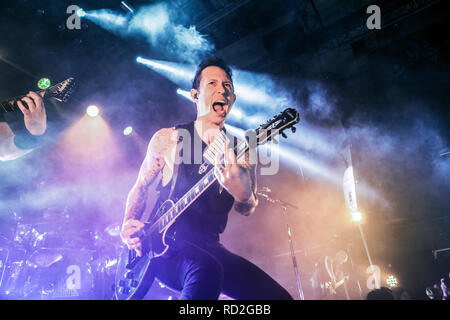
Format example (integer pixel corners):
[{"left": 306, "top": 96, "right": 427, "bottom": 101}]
[{"left": 255, "top": 108, "right": 300, "bottom": 145}]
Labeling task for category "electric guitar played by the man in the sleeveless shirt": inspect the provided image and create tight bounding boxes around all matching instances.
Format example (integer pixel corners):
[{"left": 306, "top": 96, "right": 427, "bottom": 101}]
[{"left": 114, "top": 108, "right": 299, "bottom": 300}]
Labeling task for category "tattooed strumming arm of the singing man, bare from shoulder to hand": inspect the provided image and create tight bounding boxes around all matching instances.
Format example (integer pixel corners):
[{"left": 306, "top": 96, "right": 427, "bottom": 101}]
[{"left": 120, "top": 128, "right": 176, "bottom": 255}]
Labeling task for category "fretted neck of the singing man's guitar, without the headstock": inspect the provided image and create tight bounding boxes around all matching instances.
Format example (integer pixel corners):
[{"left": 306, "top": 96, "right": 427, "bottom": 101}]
[{"left": 146, "top": 140, "right": 249, "bottom": 235}]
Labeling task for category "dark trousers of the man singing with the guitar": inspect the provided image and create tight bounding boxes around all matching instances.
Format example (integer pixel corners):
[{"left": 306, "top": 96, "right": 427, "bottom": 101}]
[{"left": 152, "top": 241, "right": 292, "bottom": 300}]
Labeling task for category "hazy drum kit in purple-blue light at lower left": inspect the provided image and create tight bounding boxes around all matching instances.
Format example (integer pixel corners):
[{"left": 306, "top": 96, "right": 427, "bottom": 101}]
[{"left": 0, "top": 207, "right": 122, "bottom": 300}]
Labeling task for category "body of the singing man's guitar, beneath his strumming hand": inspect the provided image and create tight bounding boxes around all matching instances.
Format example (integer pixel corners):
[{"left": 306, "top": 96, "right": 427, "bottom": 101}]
[{"left": 114, "top": 200, "right": 175, "bottom": 300}]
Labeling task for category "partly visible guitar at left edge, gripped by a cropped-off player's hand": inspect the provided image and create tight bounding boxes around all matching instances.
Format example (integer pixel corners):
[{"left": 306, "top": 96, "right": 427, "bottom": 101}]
[{"left": 0, "top": 78, "right": 76, "bottom": 114}]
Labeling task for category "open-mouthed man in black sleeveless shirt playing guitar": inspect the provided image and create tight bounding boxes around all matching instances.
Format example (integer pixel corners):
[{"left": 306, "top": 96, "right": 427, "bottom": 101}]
[{"left": 121, "top": 57, "right": 292, "bottom": 300}]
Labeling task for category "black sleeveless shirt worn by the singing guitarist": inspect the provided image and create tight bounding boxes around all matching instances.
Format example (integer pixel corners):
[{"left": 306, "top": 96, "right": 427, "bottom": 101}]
[{"left": 156, "top": 122, "right": 234, "bottom": 244}]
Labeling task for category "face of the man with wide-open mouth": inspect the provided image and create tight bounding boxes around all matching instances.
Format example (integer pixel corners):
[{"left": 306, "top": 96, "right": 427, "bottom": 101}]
[{"left": 192, "top": 66, "right": 236, "bottom": 125}]
